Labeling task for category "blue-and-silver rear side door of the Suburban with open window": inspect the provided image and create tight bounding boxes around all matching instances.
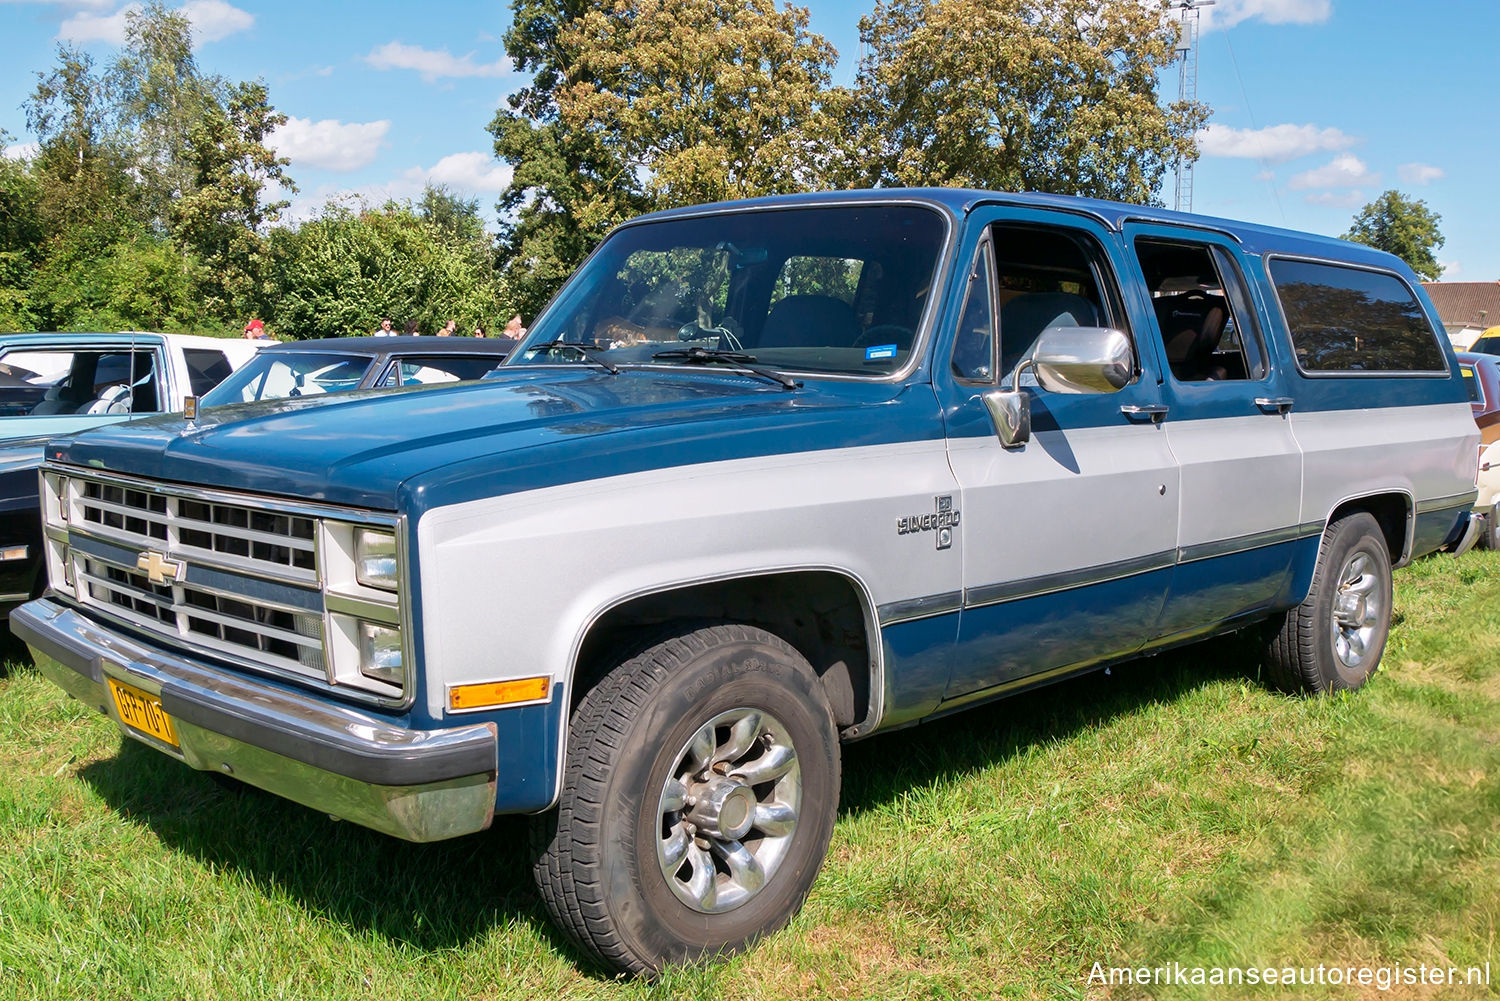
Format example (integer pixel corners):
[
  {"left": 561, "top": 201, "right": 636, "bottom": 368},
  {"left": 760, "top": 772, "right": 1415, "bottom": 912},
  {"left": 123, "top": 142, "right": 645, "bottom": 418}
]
[{"left": 1125, "top": 224, "right": 1302, "bottom": 641}]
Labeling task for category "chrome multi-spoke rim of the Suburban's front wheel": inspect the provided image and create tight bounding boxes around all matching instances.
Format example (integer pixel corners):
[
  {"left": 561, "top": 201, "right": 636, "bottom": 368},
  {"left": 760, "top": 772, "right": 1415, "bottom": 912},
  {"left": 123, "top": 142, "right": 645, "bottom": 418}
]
[{"left": 657, "top": 708, "right": 803, "bottom": 914}]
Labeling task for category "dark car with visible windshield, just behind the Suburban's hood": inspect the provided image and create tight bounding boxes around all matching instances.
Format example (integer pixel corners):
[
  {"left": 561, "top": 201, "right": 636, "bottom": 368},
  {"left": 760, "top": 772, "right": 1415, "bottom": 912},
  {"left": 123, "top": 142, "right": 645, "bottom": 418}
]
[{"left": 198, "top": 336, "right": 515, "bottom": 407}]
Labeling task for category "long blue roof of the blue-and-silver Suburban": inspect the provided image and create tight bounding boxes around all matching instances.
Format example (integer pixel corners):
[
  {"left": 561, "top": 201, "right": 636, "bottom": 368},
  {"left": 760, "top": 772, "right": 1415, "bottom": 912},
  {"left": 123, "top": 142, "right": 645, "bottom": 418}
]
[{"left": 626, "top": 188, "right": 1415, "bottom": 279}]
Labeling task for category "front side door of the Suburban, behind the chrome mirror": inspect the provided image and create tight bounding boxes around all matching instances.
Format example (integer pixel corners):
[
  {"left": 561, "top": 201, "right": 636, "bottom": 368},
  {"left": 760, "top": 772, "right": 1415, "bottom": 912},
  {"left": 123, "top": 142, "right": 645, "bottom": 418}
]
[{"left": 935, "top": 207, "right": 1179, "bottom": 701}]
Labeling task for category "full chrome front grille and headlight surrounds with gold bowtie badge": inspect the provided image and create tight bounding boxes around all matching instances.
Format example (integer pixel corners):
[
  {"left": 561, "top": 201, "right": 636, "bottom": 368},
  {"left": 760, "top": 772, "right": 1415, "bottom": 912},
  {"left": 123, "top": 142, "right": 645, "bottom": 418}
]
[{"left": 52, "top": 465, "right": 413, "bottom": 707}]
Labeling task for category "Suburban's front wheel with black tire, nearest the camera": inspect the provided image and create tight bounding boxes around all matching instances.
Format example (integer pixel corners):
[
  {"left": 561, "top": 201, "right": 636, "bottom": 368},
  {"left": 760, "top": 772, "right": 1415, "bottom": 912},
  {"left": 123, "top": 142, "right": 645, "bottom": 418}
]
[{"left": 533, "top": 624, "right": 839, "bottom": 974}]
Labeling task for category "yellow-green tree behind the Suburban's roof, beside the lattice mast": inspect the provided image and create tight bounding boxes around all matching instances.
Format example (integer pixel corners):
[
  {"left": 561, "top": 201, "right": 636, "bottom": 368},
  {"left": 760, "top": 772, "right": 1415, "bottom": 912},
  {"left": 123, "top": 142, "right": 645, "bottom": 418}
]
[{"left": 846, "top": 0, "right": 1208, "bottom": 203}]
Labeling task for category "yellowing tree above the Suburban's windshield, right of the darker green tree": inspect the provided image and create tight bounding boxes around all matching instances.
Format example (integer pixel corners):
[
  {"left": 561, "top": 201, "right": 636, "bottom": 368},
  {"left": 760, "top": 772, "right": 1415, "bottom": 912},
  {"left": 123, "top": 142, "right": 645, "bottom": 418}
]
[{"left": 557, "top": 0, "right": 839, "bottom": 209}]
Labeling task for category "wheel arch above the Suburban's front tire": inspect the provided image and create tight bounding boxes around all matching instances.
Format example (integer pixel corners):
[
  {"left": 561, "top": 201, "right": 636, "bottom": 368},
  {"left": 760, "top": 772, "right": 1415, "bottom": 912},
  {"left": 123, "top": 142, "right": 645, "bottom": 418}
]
[{"left": 564, "top": 566, "right": 884, "bottom": 732}]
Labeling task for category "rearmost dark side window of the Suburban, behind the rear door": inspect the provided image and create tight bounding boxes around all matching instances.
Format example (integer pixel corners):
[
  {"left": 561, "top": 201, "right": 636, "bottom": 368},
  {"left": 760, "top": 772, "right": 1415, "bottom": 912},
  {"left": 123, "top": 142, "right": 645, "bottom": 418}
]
[{"left": 1271, "top": 258, "right": 1448, "bottom": 372}]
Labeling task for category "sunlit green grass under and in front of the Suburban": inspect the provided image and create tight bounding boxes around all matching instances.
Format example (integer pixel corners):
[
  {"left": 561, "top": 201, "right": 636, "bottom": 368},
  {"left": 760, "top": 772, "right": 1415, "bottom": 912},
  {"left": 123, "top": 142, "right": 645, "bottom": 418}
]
[{"left": 0, "top": 552, "right": 1500, "bottom": 1001}]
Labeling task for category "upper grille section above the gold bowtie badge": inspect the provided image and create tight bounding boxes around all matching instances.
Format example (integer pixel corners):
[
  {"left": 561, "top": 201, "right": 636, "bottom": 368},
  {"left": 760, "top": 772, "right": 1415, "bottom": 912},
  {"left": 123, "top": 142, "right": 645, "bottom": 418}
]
[{"left": 74, "top": 480, "right": 318, "bottom": 584}]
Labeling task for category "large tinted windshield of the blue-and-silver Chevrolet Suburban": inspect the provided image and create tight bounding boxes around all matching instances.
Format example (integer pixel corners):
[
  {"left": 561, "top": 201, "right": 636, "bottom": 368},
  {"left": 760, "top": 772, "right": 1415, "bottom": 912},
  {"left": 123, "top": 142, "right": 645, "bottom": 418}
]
[{"left": 510, "top": 206, "right": 945, "bottom": 375}]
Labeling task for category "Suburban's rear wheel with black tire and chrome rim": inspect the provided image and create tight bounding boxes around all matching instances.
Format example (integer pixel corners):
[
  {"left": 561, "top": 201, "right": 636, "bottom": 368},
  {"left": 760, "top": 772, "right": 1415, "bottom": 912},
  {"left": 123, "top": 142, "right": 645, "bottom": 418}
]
[{"left": 1266, "top": 512, "right": 1391, "bottom": 695}]
